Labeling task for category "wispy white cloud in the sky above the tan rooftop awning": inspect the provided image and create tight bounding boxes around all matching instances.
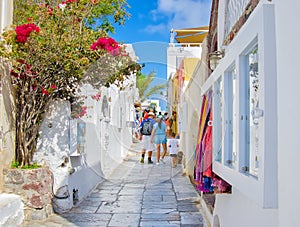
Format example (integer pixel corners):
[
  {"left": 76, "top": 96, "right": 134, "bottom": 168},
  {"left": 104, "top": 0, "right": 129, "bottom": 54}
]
[{"left": 152, "top": 0, "right": 212, "bottom": 29}]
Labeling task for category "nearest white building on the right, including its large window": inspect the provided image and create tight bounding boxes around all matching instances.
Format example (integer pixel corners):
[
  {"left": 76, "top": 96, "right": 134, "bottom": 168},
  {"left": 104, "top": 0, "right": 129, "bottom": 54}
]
[{"left": 201, "top": 0, "right": 300, "bottom": 227}]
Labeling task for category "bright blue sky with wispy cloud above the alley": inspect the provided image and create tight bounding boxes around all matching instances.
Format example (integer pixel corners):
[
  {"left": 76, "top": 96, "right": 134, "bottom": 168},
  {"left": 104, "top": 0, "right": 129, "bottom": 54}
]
[{"left": 112, "top": 0, "right": 212, "bottom": 110}]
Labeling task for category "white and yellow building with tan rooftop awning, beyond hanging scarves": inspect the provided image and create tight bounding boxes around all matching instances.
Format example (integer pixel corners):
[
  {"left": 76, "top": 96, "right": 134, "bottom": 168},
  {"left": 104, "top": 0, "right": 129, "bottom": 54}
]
[{"left": 167, "top": 26, "right": 208, "bottom": 176}]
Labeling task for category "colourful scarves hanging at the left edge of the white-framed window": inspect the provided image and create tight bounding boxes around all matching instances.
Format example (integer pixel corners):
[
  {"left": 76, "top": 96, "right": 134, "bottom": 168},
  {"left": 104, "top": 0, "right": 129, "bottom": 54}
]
[{"left": 195, "top": 91, "right": 213, "bottom": 192}]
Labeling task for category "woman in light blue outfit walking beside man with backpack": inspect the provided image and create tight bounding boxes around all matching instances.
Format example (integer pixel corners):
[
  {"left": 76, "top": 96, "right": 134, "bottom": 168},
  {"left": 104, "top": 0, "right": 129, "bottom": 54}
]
[{"left": 151, "top": 115, "right": 167, "bottom": 165}]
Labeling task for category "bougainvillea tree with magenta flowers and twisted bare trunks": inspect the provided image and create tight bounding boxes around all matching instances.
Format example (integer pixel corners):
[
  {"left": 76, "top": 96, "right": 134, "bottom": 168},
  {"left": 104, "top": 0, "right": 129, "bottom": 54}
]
[{"left": 0, "top": 0, "right": 140, "bottom": 166}]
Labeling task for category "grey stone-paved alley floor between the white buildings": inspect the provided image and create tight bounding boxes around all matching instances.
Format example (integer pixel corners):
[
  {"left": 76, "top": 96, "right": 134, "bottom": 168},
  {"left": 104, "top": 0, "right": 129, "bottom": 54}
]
[{"left": 22, "top": 144, "right": 208, "bottom": 227}]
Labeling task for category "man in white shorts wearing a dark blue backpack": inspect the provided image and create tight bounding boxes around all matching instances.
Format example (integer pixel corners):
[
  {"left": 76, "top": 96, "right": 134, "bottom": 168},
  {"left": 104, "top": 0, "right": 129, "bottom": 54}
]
[{"left": 140, "top": 112, "right": 155, "bottom": 164}]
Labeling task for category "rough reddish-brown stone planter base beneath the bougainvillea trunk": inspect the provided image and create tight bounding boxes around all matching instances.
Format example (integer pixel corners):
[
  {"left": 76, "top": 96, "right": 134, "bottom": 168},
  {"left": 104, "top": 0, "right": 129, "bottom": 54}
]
[{"left": 3, "top": 168, "right": 53, "bottom": 220}]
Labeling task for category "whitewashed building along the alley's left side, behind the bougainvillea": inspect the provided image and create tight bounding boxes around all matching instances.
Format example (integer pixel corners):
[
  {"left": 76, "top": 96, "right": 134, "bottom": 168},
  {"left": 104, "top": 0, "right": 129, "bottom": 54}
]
[{"left": 34, "top": 45, "right": 137, "bottom": 213}]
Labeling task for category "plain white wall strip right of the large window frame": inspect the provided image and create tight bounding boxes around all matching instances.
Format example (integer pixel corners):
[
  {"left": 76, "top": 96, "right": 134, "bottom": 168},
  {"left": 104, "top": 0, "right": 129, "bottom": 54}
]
[{"left": 273, "top": 0, "right": 300, "bottom": 227}]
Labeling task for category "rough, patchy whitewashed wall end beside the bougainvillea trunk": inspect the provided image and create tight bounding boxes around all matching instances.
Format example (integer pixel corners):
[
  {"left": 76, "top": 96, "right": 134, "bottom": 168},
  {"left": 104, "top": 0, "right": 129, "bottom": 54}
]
[{"left": 33, "top": 100, "right": 73, "bottom": 213}]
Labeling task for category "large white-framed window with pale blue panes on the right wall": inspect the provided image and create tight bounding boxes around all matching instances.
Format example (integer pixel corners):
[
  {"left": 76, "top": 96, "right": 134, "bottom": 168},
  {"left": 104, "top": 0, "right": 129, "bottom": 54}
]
[{"left": 207, "top": 4, "right": 278, "bottom": 208}]
